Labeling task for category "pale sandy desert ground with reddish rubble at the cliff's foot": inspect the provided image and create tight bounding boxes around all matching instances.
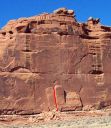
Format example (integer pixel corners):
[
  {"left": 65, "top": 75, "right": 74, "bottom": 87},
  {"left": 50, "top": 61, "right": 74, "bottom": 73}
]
[{"left": 0, "top": 110, "right": 111, "bottom": 128}]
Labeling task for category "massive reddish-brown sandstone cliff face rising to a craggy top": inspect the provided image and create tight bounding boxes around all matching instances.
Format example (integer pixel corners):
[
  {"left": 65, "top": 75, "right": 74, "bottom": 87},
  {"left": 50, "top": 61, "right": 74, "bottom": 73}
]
[{"left": 0, "top": 8, "right": 111, "bottom": 114}]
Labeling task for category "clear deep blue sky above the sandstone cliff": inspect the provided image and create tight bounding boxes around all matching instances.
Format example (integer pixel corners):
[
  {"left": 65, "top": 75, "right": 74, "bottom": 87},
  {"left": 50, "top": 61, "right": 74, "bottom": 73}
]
[{"left": 0, "top": 0, "right": 111, "bottom": 28}]
